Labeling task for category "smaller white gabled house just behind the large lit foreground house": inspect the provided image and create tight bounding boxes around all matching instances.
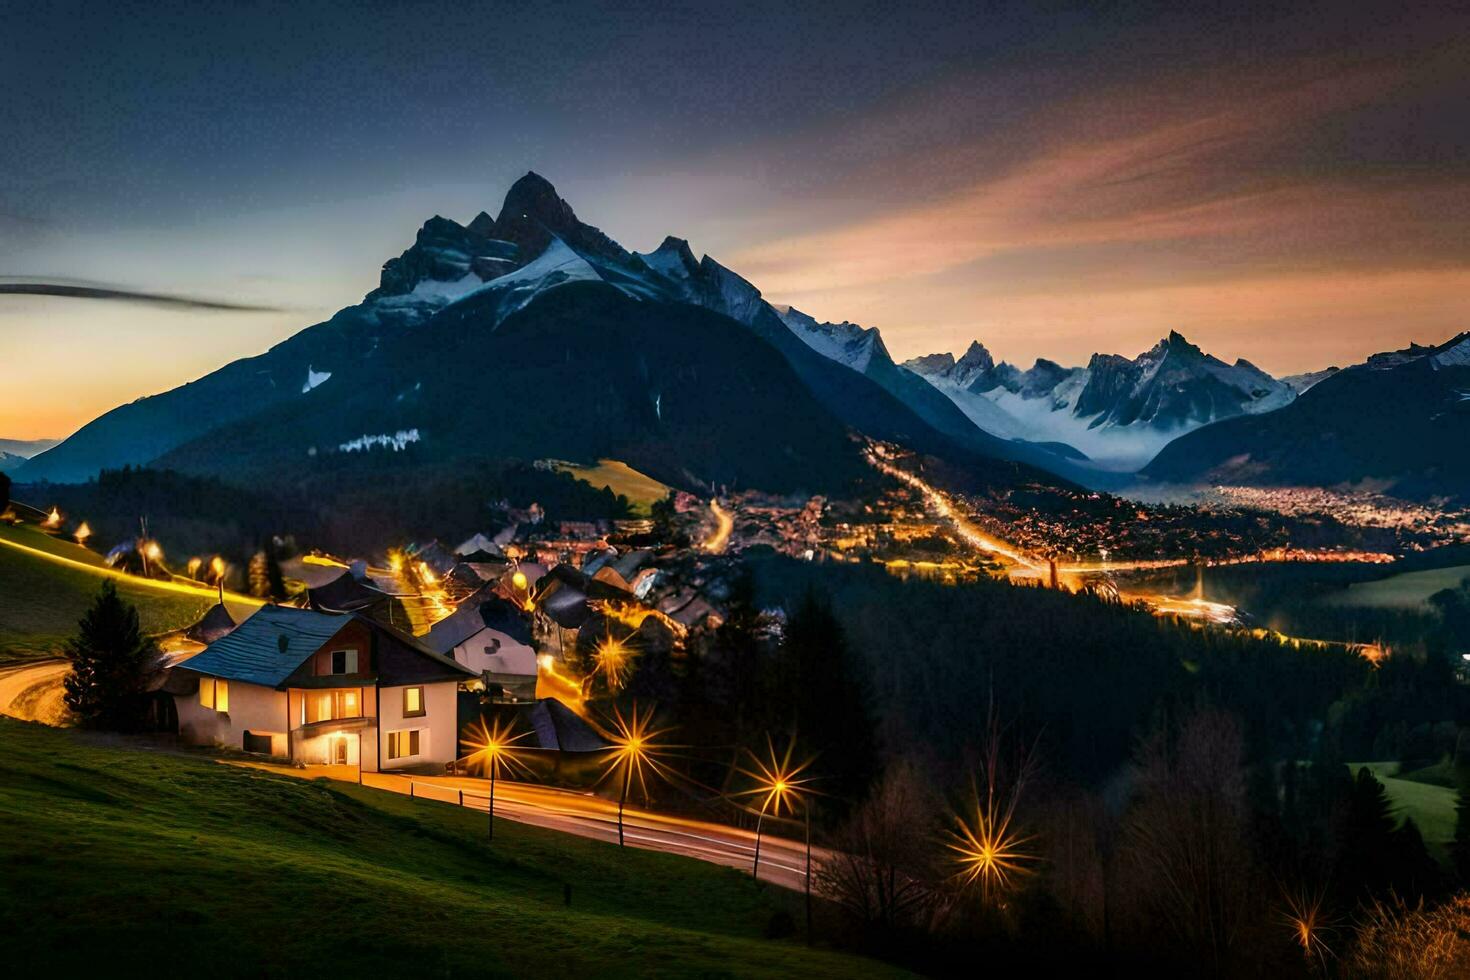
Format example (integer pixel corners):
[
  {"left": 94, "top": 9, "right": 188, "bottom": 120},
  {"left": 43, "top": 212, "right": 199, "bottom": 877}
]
[{"left": 423, "top": 588, "right": 537, "bottom": 701}]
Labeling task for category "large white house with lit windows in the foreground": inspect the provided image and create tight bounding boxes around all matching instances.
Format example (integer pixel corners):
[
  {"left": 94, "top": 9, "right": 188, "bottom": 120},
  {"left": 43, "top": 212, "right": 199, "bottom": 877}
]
[{"left": 166, "top": 605, "right": 476, "bottom": 771}]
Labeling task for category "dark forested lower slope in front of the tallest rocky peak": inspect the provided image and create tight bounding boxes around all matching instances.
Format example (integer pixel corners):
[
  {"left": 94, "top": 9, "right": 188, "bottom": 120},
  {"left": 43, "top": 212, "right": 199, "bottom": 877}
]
[{"left": 159, "top": 281, "right": 866, "bottom": 492}]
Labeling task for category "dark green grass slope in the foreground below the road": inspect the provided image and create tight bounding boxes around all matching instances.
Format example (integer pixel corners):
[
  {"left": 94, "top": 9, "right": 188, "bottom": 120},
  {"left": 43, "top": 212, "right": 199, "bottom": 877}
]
[{"left": 0, "top": 718, "right": 894, "bottom": 979}]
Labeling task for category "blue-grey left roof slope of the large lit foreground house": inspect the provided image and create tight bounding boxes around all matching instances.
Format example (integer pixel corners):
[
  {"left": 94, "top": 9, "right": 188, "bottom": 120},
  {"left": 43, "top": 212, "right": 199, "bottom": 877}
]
[{"left": 182, "top": 605, "right": 353, "bottom": 688}]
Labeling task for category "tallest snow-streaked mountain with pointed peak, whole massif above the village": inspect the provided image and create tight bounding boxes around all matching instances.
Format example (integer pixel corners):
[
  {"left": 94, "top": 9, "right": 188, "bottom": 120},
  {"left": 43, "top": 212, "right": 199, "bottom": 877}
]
[{"left": 18, "top": 173, "right": 1067, "bottom": 499}]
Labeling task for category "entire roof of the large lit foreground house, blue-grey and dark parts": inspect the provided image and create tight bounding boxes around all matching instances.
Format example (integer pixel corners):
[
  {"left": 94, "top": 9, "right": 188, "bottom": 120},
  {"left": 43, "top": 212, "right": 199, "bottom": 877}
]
[{"left": 181, "top": 605, "right": 475, "bottom": 688}]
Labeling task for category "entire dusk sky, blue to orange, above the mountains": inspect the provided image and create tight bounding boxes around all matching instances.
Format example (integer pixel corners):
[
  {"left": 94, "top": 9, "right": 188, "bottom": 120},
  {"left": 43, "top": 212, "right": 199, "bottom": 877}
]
[{"left": 0, "top": 0, "right": 1470, "bottom": 438}]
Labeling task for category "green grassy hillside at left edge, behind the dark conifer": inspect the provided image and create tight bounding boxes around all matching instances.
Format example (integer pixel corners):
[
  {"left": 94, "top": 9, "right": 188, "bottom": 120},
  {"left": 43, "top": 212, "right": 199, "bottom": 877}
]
[{"left": 0, "top": 525, "right": 254, "bottom": 663}]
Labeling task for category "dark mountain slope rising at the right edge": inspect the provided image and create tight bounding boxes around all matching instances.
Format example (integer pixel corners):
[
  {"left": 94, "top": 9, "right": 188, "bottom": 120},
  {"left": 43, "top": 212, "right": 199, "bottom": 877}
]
[{"left": 1142, "top": 334, "right": 1470, "bottom": 500}]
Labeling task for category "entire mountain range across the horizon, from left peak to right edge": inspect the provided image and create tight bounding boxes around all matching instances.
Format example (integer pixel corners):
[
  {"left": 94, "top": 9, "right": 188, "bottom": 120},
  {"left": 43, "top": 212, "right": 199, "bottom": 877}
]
[{"left": 17, "top": 173, "right": 1470, "bottom": 505}]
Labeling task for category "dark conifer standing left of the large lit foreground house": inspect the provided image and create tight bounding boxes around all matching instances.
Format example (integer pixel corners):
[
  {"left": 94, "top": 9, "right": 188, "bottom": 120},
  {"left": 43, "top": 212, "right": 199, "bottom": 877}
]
[{"left": 65, "top": 580, "right": 162, "bottom": 732}]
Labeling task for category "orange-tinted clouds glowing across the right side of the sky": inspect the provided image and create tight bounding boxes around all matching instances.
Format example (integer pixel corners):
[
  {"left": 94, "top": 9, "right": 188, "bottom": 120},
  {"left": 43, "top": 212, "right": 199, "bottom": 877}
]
[{"left": 732, "top": 57, "right": 1470, "bottom": 370}]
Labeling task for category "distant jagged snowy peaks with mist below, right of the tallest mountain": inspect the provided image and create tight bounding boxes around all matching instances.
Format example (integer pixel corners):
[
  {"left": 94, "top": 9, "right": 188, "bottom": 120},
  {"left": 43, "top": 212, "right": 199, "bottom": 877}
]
[{"left": 904, "top": 332, "right": 1295, "bottom": 472}]
